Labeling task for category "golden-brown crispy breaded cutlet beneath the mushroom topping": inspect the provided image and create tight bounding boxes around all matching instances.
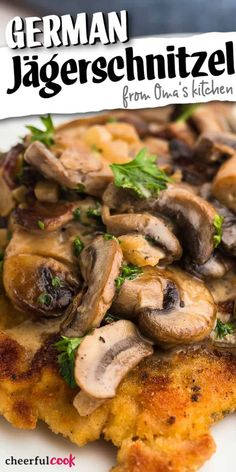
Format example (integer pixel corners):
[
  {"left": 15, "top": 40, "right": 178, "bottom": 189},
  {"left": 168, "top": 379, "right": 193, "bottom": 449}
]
[{"left": 0, "top": 294, "right": 236, "bottom": 472}]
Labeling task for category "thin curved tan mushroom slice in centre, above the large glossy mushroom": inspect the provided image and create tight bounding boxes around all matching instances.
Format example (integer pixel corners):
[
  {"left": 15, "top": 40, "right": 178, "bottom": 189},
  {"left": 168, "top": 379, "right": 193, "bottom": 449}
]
[{"left": 102, "top": 206, "right": 182, "bottom": 264}]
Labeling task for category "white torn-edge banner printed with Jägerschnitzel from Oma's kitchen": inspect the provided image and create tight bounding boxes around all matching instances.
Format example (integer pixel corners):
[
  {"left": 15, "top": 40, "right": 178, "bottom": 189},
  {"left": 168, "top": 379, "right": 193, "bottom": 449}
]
[{"left": 0, "top": 32, "right": 236, "bottom": 119}]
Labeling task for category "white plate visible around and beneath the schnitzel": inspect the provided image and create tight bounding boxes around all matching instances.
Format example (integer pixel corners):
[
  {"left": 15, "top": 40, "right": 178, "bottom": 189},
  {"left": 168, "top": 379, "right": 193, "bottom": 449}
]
[{"left": 0, "top": 115, "right": 236, "bottom": 472}]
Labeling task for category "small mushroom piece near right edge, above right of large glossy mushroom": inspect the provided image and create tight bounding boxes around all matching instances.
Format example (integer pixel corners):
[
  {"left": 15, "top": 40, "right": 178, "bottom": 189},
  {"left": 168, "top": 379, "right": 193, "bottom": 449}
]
[{"left": 185, "top": 251, "right": 233, "bottom": 279}]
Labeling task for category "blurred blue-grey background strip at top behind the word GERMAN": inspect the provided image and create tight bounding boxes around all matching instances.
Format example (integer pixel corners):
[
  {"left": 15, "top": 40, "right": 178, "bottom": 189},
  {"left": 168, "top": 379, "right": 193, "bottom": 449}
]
[{"left": 0, "top": 0, "right": 236, "bottom": 45}]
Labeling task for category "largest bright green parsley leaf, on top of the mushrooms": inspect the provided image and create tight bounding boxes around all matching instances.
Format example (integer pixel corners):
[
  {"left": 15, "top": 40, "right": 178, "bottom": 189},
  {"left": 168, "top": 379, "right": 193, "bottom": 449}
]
[{"left": 110, "top": 148, "right": 171, "bottom": 198}]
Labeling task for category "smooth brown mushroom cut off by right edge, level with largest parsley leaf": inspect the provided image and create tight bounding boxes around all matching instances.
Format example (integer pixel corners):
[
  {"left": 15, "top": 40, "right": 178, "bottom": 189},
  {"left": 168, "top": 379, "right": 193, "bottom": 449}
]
[{"left": 212, "top": 154, "right": 236, "bottom": 213}]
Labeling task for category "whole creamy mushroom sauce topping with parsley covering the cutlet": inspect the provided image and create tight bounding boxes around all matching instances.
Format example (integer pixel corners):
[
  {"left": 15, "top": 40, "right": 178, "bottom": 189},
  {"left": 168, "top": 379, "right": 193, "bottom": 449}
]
[{"left": 0, "top": 103, "right": 236, "bottom": 415}]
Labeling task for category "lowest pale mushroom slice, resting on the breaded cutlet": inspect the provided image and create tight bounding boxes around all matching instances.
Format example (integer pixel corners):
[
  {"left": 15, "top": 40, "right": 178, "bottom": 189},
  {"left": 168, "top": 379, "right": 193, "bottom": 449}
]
[{"left": 75, "top": 320, "right": 153, "bottom": 399}]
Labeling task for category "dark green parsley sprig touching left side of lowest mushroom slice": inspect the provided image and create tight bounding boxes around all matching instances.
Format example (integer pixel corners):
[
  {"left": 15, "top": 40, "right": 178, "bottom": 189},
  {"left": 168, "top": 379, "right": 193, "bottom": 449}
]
[{"left": 54, "top": 336, "right": 85, "bottom": 388}]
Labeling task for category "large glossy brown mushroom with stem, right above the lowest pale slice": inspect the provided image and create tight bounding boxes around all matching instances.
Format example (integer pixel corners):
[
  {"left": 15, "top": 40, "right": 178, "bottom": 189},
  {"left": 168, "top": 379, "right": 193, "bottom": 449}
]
[{"left": 111, "top": 267, "right": 216, "bottom": 347}]
